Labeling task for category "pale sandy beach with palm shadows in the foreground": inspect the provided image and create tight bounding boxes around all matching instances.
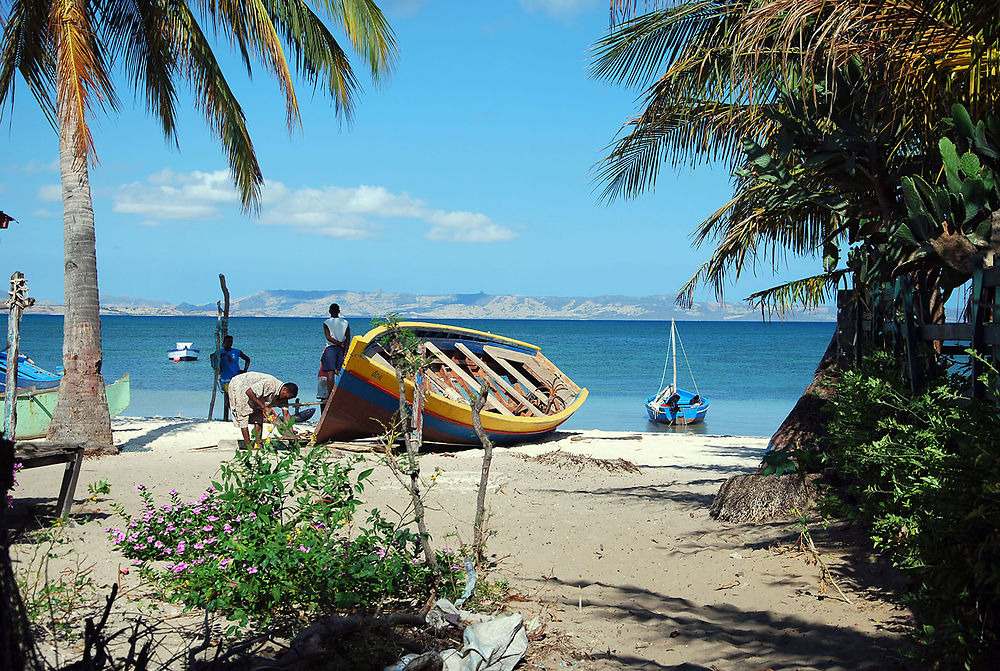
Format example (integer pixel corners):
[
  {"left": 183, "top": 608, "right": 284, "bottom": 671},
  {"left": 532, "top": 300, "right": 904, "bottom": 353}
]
[{"left": 12, "top": 418, "right": 909, "bottom": 670}]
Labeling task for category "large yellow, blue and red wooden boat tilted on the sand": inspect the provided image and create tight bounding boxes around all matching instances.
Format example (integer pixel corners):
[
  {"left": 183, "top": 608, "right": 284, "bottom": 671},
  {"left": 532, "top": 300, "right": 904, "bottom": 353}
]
[{"left": 316, "top": 322, "right": 587, "bottom": 445}]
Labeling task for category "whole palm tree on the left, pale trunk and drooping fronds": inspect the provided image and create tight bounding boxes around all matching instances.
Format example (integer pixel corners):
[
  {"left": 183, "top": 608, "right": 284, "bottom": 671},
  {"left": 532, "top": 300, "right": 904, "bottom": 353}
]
[{"left": 0, "top": 0, "right": 396, "bottom": 453}]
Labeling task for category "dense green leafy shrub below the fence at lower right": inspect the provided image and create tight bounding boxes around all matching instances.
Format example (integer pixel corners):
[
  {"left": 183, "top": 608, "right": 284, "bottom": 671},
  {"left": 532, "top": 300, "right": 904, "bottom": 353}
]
[{"left": 822, "top": 353, "right": 1000, "bottom": 669}]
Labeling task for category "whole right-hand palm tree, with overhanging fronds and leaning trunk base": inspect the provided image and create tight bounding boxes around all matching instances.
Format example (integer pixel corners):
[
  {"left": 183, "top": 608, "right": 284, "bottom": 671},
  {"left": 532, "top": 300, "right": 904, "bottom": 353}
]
[{"left": 593, "top": 0, "right": 1000, "bottom": 521}]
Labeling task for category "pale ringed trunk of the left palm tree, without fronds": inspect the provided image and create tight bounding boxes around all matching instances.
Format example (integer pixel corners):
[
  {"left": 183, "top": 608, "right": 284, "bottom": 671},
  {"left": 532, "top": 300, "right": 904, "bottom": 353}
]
[{"left": 48, "top": 56, "right": 118, "bottom": 454}]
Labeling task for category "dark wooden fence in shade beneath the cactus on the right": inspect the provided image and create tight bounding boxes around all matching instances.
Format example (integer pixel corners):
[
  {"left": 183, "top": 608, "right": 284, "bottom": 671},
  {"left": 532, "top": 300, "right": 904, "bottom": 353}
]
[{"left": 837, "top": 256, "right": 1000, "bottom": 398}]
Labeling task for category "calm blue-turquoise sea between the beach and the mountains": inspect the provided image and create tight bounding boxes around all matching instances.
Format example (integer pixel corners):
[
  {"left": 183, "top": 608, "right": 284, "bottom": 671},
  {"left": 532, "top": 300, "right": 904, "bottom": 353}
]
[{"left": 0, "top": 314, "right": 835, "bottom": 436}]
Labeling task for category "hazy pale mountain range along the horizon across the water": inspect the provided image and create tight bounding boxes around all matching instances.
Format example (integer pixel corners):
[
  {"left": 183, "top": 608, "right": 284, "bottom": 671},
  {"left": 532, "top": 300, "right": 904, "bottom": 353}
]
[{"left": 29, "top": 289, "right": 836, "bottom": 321}]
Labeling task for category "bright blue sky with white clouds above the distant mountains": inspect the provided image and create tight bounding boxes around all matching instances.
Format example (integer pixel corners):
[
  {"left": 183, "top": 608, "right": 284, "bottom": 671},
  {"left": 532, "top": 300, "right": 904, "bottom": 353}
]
[{"left": 0, "top": 0, "right": 819, "bottom": 304}]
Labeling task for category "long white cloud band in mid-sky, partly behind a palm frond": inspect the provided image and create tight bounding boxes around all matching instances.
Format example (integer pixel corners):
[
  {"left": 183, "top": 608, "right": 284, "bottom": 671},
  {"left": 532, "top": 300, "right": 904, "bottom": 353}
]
[{"left": 112, "top": 168, "right": 517, "bottom": 242}]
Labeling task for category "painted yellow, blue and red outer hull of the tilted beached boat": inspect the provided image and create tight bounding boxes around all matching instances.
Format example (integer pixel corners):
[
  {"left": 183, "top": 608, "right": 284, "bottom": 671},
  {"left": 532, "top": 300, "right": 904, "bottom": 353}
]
[{"left": 316, "top": 324, "right": 588, "bottom": 445}]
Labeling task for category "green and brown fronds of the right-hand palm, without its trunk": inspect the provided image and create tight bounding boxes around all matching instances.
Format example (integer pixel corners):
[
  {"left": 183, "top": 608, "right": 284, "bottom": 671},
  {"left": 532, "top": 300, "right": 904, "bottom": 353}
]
[{"left": 593, "top": 0, "right": 1000, "bottom": 309}]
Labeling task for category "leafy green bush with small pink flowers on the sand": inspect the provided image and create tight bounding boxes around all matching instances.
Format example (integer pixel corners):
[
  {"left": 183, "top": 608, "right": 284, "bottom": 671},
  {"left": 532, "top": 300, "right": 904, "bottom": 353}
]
[{"left": 107, "top": 438, "right": 461, "bottom": 623}]
